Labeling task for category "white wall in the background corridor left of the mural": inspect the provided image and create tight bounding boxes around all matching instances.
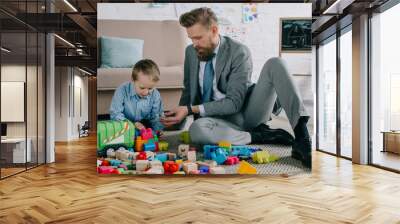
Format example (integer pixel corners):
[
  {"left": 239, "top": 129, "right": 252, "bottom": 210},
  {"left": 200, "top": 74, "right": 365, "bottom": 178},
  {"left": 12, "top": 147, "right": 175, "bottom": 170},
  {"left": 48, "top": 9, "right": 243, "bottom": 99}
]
[{"left": 55, "top": 67, "right": 88, "bottom": 141}]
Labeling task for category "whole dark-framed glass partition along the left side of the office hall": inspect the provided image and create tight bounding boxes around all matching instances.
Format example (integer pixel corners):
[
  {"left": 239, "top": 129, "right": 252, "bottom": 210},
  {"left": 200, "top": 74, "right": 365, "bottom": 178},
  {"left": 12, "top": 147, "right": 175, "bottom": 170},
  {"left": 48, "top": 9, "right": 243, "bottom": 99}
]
[{"left": 0, "top": 1, "right": 46, "bottom": 179}]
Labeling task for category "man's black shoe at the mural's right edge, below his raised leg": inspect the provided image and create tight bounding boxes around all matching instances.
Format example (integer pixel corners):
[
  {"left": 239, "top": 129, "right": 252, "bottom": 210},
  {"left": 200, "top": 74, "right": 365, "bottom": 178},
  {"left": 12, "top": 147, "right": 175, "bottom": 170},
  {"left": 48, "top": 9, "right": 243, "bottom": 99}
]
[{"left": 292, "top": 138, "right": 312, "bottom": 169}]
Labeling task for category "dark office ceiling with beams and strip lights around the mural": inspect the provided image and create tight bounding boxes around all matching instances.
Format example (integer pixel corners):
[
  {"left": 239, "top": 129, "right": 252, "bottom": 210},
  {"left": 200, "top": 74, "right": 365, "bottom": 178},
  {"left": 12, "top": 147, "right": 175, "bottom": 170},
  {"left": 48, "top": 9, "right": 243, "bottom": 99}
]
[{"left": 0, "top": 0, "right": 394, "bottom": 72}]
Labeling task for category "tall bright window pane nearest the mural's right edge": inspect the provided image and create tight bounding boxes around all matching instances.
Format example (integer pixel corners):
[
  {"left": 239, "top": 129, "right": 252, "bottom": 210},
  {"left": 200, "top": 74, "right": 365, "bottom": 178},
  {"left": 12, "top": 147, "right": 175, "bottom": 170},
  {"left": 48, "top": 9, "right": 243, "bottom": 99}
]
[{"left": 318, "top": 39, "right": 336, "bottom": 156}]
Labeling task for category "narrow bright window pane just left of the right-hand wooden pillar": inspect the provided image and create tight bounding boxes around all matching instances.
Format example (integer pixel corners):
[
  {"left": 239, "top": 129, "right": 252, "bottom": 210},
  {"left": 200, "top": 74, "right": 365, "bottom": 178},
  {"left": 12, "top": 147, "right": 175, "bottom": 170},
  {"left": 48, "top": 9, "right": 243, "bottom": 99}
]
[{"left": 340, "top": 30, "right": 353, "bottom": 158}]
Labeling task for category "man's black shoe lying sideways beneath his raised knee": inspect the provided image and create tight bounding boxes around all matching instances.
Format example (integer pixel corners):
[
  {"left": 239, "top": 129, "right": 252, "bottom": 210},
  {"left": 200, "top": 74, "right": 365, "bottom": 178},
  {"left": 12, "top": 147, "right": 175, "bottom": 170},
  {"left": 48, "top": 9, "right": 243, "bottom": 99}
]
[{"left": 250, "top": 124, "right": 294, "bottom": 145}]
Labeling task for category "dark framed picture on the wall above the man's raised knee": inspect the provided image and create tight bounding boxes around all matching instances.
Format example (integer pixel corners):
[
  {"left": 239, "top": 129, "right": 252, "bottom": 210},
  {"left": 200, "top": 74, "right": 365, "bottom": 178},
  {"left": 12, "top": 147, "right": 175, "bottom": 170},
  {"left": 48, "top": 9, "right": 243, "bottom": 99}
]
[{"left": 280, "top": 18, "right": 311, "bottom": 52}]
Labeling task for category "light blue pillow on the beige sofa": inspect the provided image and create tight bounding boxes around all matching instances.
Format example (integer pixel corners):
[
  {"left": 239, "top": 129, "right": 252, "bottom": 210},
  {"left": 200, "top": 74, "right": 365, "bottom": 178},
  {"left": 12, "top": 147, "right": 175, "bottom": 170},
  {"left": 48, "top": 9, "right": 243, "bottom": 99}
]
[{"left": 100, "top": 36, "right": 144, "bottom": 68}]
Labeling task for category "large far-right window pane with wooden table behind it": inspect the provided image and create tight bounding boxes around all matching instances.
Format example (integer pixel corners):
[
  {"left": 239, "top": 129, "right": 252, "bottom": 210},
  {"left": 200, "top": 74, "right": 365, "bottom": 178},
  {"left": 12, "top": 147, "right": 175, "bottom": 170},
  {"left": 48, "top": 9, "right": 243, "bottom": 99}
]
[{"left": 371, "top": 5, "right": 400, "bottom": 170}]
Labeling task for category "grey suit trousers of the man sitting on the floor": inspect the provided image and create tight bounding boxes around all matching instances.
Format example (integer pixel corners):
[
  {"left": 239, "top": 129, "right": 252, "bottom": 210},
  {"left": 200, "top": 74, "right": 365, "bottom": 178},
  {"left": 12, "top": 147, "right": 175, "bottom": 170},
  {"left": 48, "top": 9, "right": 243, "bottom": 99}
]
[{"left": 189, "top": 58, "right": 308, "bottom": 145}]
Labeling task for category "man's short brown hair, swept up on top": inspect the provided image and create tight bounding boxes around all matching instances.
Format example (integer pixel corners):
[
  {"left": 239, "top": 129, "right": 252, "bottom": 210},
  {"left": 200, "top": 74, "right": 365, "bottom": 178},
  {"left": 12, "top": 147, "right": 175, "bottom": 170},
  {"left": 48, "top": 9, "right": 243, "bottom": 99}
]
[{"left": 179, "top": 7, "right": 218, "bottom": 29}]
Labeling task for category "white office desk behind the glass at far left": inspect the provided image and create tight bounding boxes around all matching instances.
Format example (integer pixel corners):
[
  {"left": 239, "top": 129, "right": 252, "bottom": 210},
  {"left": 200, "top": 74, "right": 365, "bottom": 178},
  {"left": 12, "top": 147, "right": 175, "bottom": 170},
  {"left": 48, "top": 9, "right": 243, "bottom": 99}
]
[{"left": 1, "top": 138, "right": 32, "bottom": 163}]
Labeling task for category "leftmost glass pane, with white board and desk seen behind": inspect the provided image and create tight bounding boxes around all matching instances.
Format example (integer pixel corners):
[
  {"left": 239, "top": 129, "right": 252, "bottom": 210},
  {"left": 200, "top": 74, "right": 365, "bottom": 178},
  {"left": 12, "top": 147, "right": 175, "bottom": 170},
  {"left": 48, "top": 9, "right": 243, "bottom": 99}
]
[{"left": 0, "top": 17, "right": 30, "bottom": 178}]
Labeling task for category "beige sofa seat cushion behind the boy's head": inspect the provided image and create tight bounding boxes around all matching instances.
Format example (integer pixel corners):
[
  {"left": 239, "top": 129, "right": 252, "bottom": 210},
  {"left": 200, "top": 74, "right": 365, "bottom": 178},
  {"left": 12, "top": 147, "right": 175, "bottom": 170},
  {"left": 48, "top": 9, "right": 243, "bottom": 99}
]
[{"left": 97, "top": 66, "right": 183, "bottom": 90}]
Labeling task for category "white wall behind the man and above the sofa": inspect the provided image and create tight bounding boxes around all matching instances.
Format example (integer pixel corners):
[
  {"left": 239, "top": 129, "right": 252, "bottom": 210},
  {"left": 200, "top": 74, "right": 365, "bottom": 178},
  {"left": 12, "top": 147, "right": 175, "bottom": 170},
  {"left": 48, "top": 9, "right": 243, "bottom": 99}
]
[{"left": 97, "top": 3, "right": 311, "bottom": 82}]
